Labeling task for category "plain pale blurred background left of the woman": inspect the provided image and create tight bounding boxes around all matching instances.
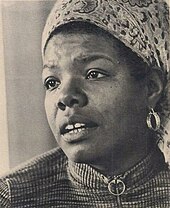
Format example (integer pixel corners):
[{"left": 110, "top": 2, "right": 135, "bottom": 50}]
[{"left": 0, "top": 1, "right": 56, "bottom": 174}]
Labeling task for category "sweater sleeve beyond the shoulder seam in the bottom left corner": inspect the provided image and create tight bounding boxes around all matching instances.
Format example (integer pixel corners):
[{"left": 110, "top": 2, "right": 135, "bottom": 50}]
[{"left": 0, "top": 179, "right": 10, "bottom": 208}]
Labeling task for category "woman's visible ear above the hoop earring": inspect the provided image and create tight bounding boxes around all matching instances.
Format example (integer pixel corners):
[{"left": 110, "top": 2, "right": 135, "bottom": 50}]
[{"left": 147, "top": 70, "right": 163, "bottom": 108}]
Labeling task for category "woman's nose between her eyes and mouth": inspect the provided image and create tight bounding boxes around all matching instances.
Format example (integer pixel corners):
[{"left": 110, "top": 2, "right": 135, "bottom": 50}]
[{"left": 57, "top": 81, "right": 88, "bottom": 111}]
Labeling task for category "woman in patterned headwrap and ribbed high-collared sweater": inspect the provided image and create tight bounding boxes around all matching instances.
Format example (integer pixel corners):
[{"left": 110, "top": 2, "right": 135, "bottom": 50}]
[{"left": 0, "top": 0, "right": 170, "bottom": 208}]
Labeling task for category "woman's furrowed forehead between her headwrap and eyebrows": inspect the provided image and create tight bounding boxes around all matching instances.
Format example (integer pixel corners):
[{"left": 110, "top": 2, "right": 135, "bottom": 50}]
[{"left": 44, "top": 32, "right": 122, "bottom": 67}]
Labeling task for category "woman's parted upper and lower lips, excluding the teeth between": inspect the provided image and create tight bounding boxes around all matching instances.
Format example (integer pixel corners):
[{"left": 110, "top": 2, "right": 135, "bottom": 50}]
[{"left": 59, "top": 115, "right": 99, "bottom": 143}]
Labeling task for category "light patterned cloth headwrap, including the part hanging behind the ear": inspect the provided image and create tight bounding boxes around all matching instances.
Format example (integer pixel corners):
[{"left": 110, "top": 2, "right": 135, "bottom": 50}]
[{"left": 42, "top": 0, "right": 170, "bottom": 164}]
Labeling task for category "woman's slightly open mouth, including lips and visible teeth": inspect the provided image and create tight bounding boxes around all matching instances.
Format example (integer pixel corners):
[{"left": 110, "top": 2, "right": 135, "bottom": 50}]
[{"left": 60, "top": 121, "right": 98, "bottom": 142}]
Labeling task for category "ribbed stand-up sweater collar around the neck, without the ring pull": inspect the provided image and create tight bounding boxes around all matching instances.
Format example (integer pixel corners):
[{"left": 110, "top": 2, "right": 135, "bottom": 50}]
[{"left": 68, "top": 147, "right": 165, "bottom": 189}]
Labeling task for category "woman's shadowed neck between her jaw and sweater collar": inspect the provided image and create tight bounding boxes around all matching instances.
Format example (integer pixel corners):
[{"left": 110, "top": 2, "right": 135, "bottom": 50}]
[{"left": 91, "top": 132, "right": 155, "bottom": 176}]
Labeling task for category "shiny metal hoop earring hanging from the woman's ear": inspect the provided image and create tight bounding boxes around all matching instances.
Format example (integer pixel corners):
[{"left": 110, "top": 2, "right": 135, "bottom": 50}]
[{"left": 146, "top": 108, "right": 161, "bottom": 131}]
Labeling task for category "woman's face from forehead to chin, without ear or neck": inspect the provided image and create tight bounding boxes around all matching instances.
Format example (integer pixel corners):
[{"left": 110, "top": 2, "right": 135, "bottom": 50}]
[{"left": 42, "top": 33, "right": 147, "bottom": 164}]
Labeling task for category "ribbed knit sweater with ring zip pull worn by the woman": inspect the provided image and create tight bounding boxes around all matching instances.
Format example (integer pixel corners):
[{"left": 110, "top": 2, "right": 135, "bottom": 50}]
[{"left": 0, "top": 148, "right": 170, "bottom": 208}]
